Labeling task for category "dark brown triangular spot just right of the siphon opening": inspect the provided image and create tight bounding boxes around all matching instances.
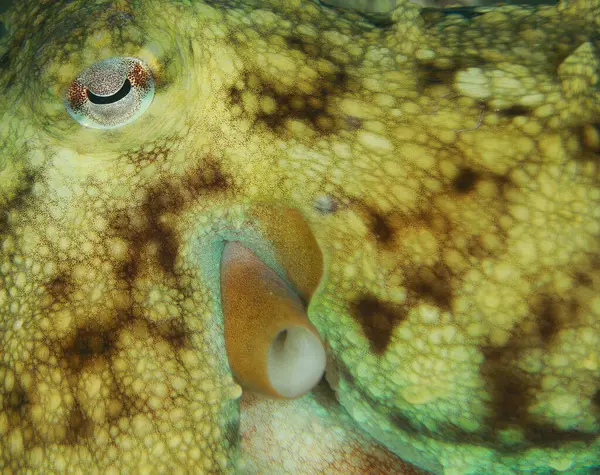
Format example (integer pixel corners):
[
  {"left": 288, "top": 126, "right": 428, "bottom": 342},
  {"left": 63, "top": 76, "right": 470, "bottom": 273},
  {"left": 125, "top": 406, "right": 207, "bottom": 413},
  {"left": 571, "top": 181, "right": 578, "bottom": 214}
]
[{"left": 350, "top": 295, "right": 407, "bottom": 355}]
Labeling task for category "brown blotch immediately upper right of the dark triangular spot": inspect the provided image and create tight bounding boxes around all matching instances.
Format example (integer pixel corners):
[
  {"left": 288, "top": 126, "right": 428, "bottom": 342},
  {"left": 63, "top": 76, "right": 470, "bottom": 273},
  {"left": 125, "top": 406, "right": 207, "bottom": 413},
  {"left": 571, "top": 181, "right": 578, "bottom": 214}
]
[{"left": 405, "top": 265, "right": 453, "bottom": 310}]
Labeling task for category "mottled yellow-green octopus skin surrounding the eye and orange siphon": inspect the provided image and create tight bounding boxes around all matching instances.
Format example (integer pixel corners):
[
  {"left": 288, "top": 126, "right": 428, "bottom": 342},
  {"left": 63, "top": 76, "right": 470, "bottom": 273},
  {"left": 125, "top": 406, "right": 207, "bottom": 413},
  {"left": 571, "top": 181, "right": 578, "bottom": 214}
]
[{"left": 0, "top": 0, "right": 600, "bottom": 474}]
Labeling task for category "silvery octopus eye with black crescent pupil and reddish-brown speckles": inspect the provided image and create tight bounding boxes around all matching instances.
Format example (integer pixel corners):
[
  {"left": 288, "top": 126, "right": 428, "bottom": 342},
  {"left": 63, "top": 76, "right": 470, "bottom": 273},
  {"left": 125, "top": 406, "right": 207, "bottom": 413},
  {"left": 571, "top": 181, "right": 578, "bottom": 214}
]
[{"left": 65, "top": 57, "right": 154, "bottom": 129}]
